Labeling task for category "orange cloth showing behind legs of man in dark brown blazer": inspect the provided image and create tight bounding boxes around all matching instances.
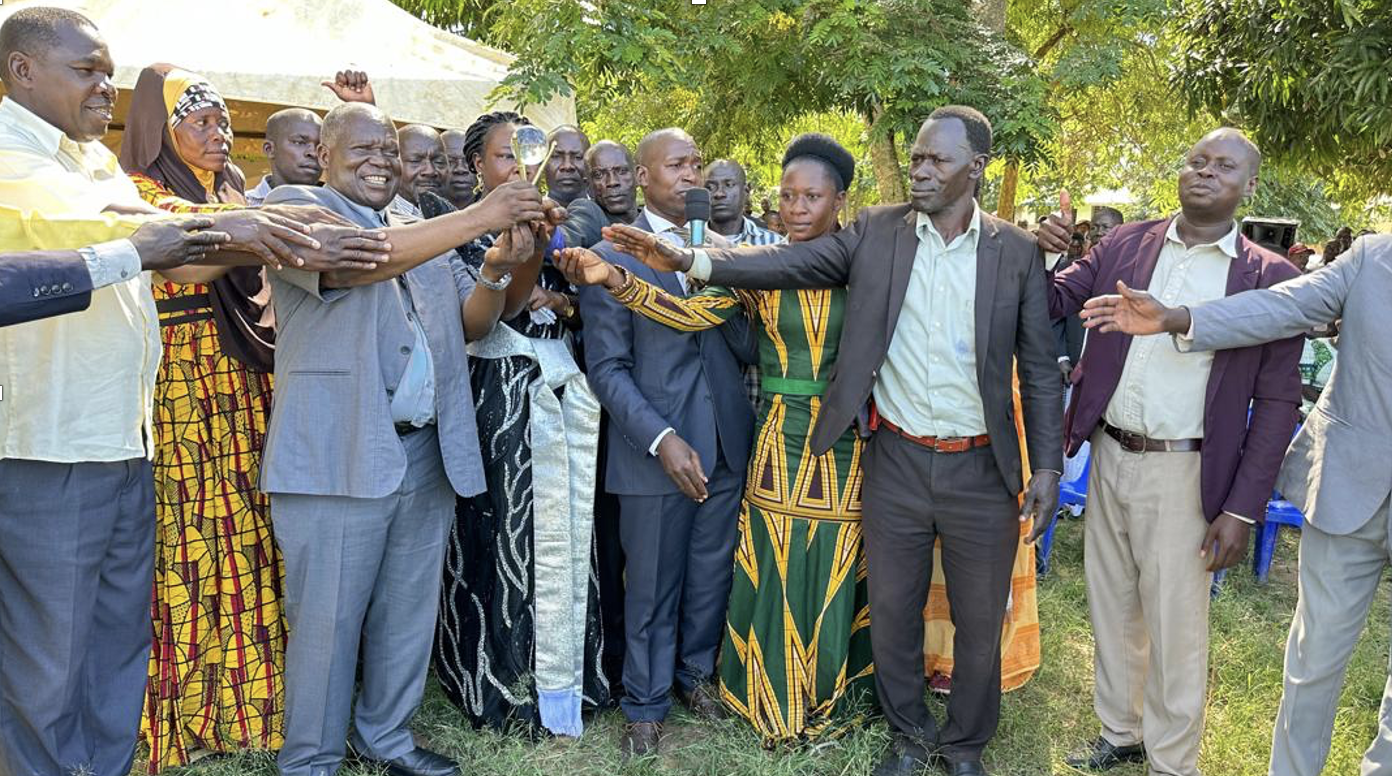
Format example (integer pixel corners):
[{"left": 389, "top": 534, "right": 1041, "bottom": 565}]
[{"left": 923, "top": 375, "right": 1040, "bottom": 692}]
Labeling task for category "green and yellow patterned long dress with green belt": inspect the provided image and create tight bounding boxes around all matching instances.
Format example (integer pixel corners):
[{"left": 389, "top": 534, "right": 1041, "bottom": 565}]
[{"left": 615, "top": 279, "right": 874, "bottom": 745}]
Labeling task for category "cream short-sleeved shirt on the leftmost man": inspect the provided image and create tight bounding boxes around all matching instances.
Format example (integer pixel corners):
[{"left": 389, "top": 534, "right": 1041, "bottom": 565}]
[{"left": 0, "top": 98, "right": 161, "bottom": 463}]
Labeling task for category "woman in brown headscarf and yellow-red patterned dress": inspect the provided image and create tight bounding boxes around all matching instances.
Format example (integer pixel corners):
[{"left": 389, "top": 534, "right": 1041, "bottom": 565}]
[{"left": 121, "top": 65, "right": 285, "bottom": 773}]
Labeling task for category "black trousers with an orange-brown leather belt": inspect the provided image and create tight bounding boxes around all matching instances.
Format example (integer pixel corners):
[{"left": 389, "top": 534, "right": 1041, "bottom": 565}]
[{"left": 862, "top": 430, "right": 1019, "bottom": 759}]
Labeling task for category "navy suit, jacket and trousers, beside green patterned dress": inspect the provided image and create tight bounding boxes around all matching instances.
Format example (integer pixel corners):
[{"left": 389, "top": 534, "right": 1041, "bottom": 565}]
[{"left": 580, "top": 216, "right": 754, "bottom": 722}]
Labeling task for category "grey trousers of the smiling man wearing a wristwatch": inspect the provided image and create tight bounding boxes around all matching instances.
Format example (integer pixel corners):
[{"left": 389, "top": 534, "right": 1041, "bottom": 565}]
[{"left": 270, "top": 426, "right": 455, "bottom": 776}]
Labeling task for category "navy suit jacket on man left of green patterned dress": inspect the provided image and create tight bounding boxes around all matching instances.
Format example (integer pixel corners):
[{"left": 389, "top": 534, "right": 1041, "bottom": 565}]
[{"left": 580, "top": 210, "right": 754, "bottom": 496}]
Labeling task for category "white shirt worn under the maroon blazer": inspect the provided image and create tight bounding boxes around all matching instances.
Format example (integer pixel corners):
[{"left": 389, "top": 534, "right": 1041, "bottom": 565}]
[{"left": 1102, "top": 219, "right": 1237, "bottom": 439}]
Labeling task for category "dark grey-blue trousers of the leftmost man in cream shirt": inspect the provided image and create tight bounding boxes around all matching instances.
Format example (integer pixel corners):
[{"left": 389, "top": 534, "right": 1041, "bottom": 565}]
[{"left": 0, "top": 458, "right": 155, "bottom": 776}]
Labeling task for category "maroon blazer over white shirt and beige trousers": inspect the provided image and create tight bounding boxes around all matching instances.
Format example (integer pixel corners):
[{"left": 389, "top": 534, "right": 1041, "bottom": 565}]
[{"left": 1050, "top": 219, "right": 1303, "bottom": 521}]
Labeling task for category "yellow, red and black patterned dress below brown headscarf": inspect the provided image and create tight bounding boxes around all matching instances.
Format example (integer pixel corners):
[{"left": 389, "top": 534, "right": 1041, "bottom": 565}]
[{"left": 131, "top": 176, "right": 285, "bottom": 773}]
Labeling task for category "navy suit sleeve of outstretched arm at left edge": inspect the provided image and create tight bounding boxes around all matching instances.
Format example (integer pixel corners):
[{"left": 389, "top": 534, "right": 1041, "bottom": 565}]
[{"left": 0, "top": 252, "right": 92, "bottom": 326}]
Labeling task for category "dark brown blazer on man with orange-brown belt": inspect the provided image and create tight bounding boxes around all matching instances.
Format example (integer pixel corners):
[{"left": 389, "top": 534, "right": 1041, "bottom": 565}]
[{"left": 710, "top": 205, "right": 1063, "bottom": 493}]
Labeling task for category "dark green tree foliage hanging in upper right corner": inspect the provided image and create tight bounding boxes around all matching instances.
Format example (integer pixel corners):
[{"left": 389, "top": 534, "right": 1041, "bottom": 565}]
[{"left": 1173, "top": 0, "right": 1392, "bottom": 199}]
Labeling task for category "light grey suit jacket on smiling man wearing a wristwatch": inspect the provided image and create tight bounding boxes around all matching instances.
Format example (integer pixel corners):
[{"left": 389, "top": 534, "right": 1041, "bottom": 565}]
[{"left": 260, "top": 185, "right": 484, "bottom": 499}]
